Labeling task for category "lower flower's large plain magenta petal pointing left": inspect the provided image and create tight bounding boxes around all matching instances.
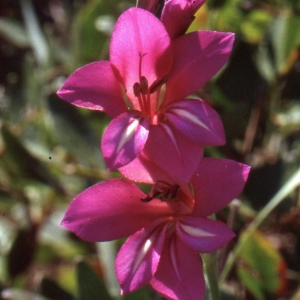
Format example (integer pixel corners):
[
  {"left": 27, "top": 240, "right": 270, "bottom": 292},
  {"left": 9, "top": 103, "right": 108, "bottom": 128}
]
[{"left": 61, "top": 179, "right": 173, "bottom": 242}]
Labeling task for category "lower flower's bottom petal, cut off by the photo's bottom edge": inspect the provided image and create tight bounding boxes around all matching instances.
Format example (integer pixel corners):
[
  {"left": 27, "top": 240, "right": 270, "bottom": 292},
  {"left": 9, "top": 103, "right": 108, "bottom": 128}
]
[{"left": 150, "top": 237, "right": 205, "bottom": 300}]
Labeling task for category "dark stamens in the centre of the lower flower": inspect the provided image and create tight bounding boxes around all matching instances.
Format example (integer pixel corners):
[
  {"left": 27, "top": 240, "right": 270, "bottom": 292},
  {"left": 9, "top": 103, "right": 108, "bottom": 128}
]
[{"left": 141, "top": 180, "right": 180, "bottom": 202}]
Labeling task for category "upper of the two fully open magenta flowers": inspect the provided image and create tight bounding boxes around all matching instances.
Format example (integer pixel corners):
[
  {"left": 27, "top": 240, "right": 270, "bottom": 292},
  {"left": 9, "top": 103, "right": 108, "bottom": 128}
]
[{"left": 58, "top": 8, "right": 234, "bottom": 181}]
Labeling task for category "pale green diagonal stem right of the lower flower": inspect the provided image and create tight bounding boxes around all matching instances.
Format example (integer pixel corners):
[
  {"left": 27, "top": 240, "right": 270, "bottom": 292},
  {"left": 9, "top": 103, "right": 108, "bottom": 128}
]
[{"left": 220, "top": 169, "right": 300, "bottom": 282}]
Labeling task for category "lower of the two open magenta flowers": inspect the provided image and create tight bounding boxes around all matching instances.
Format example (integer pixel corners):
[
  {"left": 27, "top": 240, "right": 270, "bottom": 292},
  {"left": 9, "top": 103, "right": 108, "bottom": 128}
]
[{"left": 62, "top": 158, "right": 249, "bottom": 300}]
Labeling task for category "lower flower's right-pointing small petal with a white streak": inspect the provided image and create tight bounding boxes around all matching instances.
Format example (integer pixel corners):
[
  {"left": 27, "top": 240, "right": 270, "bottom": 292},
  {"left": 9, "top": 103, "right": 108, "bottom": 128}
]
[{"left": 175, "top": 216, "right": 235, "bottom": 253}]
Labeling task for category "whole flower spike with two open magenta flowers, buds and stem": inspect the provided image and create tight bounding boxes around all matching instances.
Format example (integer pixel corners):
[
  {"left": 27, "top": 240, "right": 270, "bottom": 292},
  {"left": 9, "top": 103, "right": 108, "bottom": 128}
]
[{"left": 58, "top": 0, "right": 250, "bottom": 300}]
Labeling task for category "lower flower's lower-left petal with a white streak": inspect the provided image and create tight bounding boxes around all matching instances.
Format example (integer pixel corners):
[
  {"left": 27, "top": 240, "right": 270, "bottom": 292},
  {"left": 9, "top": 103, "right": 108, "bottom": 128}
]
[{"left": 115, "top": 218, "right": 168, "bottom": 294}]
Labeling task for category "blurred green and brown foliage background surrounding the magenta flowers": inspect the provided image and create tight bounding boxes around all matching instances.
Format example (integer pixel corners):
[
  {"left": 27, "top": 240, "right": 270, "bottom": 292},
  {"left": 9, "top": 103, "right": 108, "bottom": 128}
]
[{"left": 0, "top": 0, "right": 300, "bottom": 300}]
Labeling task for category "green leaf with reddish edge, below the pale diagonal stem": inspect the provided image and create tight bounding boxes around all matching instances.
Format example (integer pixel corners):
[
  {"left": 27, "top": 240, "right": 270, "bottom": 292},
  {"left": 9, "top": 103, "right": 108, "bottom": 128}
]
[{"left": 237, "top": 231, "right": 286, "bottom": 300}]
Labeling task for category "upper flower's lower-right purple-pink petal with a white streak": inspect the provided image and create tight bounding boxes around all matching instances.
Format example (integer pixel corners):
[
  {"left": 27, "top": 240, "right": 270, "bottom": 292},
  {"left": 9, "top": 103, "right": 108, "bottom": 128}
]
[{"left": 165, "top": 99, "right": 225, "bottom": 146}]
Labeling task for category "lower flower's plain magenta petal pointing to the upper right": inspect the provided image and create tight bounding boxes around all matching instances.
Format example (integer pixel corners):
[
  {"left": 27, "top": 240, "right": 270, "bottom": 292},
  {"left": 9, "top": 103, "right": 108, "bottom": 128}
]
[{"left": 191, "top": 158, "right": 250, "bottom": 217}]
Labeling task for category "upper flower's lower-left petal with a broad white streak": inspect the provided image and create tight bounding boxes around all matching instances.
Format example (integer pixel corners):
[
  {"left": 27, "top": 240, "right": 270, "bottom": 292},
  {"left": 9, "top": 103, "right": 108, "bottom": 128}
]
[{"left": 101, "top": 111, "right": 149, "bottom": 169}]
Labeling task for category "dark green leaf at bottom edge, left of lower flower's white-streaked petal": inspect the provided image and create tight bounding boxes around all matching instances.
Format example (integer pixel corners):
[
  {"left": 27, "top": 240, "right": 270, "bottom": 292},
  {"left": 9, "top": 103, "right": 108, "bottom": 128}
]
[{"left": 77, "top": 261, "right": 112, "bottom": 300}]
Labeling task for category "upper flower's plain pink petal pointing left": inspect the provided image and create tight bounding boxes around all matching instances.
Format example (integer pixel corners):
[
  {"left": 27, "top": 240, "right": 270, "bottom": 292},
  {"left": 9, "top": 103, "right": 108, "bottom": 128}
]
[{"left": 57, "top": 61, "right": 128, "bottom": 118}]
